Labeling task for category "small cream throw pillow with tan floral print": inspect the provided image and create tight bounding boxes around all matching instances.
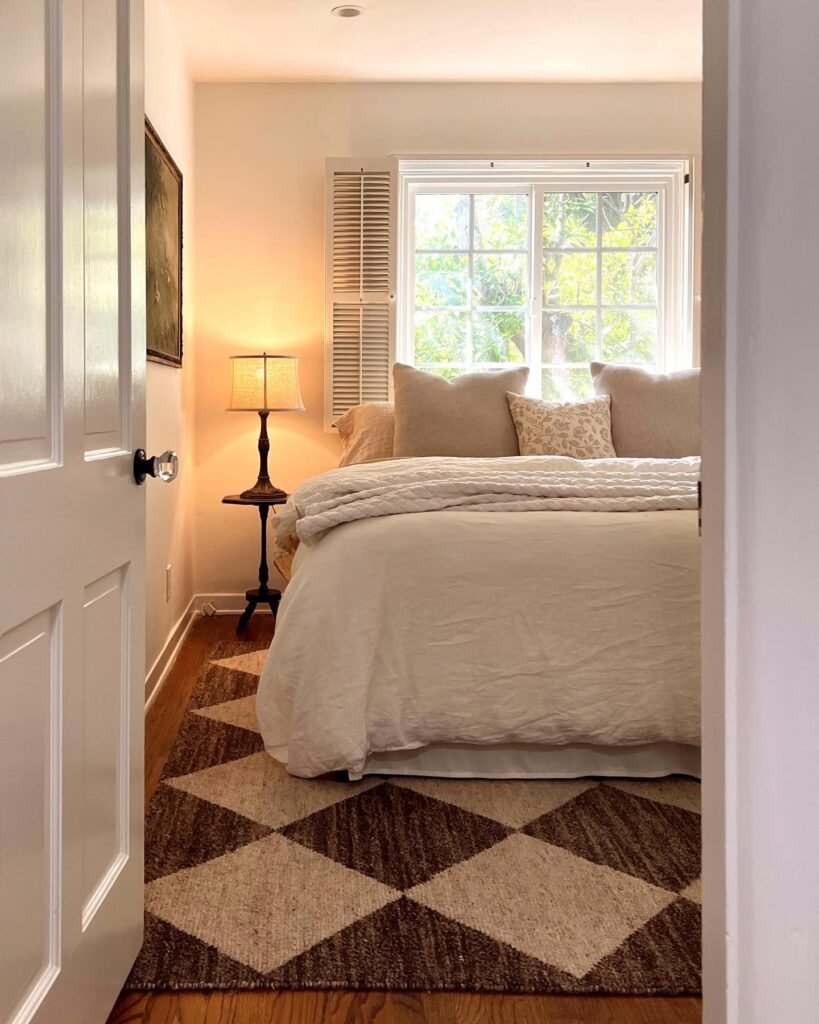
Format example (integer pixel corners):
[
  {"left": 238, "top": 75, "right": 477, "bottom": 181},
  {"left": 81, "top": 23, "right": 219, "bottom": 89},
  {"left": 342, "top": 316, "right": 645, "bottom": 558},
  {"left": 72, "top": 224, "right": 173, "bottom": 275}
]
[{"left": 507, "top": 391, "right": 616, "bottom": 459}]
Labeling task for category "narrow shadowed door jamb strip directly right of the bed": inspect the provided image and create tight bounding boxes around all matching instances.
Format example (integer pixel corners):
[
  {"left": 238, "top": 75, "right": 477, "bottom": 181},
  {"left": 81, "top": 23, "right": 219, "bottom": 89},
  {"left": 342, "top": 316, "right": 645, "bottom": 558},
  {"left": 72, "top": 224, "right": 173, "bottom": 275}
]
[{"left": 700, "top": 0, "right": 728, "bottom": 1024}]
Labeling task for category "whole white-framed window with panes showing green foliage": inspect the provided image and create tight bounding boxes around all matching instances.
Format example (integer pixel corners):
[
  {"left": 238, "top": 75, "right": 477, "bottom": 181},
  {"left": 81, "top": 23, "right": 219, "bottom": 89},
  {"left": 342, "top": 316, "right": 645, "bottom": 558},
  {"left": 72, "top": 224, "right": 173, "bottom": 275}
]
[{"left": 397, "top": 161, "right": 692, "bottom": 399}]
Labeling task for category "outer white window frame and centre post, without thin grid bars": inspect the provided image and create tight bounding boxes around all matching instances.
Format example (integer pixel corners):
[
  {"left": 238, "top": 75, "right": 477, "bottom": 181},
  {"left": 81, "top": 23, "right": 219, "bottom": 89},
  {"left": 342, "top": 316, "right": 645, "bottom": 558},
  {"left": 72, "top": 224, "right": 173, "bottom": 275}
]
[{"left": 396, "top": 157, "right": 694, "bottom": 395}]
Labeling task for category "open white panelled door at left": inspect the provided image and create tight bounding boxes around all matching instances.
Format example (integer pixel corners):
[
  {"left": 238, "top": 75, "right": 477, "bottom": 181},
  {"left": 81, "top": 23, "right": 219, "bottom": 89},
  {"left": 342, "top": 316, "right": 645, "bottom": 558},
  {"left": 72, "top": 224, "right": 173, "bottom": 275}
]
[{"left": 0, "top": 0, "right": 145, "bottom": 1024}]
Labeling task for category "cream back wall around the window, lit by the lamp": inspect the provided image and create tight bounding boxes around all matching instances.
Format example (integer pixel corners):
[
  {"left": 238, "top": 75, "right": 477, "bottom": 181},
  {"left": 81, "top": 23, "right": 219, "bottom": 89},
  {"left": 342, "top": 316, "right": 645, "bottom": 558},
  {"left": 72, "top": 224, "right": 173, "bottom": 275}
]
[{"left": 195, "top": 84, "right": 700, "bottom": 594}]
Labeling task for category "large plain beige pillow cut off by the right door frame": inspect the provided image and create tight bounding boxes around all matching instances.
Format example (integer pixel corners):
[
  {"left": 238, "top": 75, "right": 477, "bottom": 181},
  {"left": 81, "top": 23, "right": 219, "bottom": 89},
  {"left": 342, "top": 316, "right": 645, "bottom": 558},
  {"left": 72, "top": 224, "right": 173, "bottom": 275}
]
[{"left": 590, "top": 362, "right": 700, "bottom": 459}]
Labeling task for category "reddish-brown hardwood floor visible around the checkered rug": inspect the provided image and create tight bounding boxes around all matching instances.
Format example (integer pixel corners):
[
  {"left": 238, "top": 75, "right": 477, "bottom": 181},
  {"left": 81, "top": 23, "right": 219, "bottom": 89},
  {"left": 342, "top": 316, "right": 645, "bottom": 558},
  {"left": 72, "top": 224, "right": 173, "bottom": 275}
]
[{"left": 109, "top": 615, "right": 701, "bottom": 1024}]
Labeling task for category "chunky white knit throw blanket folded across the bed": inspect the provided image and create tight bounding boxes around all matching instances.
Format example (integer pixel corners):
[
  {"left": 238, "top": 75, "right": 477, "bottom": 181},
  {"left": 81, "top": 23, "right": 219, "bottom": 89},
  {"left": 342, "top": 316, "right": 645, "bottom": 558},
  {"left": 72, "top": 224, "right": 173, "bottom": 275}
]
[{"left": 273, "top": 456, "right": 699, "bottom": 552}]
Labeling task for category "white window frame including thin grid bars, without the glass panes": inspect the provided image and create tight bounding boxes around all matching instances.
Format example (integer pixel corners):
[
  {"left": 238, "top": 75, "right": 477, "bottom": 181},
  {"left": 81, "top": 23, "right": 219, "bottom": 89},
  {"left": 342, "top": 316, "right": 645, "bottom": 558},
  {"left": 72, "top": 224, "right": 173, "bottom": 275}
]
[{"left": 397, "top": 159, "right": 694, "bottom": 395}]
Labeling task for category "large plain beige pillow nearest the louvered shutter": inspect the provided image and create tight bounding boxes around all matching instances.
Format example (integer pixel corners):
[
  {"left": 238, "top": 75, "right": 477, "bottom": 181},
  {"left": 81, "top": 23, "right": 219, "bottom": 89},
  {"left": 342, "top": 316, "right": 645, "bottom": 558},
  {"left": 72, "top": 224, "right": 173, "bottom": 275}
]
[{"left": 392, "top": 362, "right": 529, "bottom": 459}]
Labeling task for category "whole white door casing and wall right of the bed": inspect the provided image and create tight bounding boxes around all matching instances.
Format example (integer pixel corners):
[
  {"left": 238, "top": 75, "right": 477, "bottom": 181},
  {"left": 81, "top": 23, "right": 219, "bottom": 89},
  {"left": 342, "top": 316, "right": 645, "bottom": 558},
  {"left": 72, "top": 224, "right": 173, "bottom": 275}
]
[{"left": 702, "top": 0, "right": 819, "bottom": 1024}]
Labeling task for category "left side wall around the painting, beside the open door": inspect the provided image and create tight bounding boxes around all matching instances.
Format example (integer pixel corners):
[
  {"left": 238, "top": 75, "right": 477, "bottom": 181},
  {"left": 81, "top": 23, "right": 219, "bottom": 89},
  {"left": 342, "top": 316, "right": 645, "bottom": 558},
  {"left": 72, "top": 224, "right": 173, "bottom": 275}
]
[{"left": 145, "top": 0, "right": 195, "bottom": 669}]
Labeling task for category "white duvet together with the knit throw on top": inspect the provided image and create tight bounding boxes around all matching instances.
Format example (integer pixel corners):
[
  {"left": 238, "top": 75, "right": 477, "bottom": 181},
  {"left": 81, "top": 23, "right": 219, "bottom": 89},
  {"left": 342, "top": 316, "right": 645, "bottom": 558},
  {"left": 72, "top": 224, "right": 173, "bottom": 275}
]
[{"left": 257, "top": 457, "right": 699, "bottom": 777}]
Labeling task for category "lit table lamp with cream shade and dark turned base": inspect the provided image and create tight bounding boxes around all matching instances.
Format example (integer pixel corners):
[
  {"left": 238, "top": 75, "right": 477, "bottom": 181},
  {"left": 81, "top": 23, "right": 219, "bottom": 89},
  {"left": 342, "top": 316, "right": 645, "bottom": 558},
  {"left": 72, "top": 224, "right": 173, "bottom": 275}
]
[{"left": 227, "top": 352, "right": 304, "bottom": 500}]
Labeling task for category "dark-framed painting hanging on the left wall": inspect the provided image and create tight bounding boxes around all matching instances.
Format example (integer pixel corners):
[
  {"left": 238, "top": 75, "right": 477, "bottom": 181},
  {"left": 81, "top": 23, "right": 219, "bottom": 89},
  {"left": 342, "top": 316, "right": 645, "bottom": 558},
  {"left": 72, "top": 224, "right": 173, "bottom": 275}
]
[{"left": 145, "top": 118, "right": 182, "bottom": 367}]
